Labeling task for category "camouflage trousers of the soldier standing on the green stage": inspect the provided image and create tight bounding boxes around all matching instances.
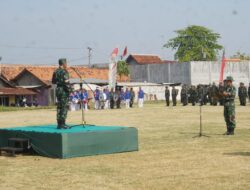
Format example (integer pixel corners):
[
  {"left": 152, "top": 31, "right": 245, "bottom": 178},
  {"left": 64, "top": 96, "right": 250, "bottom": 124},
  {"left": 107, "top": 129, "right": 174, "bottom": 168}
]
[{"left": 57, "top": 96, "right": 68, "bottom": 121}]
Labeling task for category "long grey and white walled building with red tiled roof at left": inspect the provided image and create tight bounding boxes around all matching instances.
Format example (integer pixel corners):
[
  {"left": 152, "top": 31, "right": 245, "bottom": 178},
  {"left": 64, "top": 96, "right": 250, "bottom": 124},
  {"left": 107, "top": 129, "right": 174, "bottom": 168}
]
[{"left": 126, "top": 54, "right": 250, "bottom": 86}]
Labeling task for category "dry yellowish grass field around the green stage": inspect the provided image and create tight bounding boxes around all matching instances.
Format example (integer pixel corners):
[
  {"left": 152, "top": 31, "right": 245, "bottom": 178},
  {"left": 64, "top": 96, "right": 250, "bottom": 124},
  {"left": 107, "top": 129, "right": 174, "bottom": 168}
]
[{"left": 0, "top": 104, "right": 250, "bottom": 190}]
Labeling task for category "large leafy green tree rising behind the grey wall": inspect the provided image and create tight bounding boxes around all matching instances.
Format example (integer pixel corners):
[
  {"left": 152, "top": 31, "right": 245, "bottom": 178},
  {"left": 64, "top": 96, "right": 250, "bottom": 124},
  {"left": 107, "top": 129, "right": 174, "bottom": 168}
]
[{"left": 164, "top": 25, "right": 223, "bottom": 62}]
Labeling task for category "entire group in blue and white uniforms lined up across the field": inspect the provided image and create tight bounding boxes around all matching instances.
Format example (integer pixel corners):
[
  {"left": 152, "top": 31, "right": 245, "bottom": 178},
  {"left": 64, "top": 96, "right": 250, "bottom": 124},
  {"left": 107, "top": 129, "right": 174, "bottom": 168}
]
[{"left": 70, "top": 87, "right": 144, "bottom": 111}]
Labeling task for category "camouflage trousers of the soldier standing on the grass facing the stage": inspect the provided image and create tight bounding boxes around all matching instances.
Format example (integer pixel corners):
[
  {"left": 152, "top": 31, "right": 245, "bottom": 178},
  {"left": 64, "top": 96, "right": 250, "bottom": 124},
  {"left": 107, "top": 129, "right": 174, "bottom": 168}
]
[{"left": 224, "top": 102, "right": 236, "bottom": 129}]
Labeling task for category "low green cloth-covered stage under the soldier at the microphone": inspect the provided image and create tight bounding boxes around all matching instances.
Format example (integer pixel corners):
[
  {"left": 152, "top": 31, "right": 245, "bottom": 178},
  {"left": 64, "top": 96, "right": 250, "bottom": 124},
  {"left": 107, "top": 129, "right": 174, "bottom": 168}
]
[{"left": 0, "top": 125, "right": 138, "bottom": 158}]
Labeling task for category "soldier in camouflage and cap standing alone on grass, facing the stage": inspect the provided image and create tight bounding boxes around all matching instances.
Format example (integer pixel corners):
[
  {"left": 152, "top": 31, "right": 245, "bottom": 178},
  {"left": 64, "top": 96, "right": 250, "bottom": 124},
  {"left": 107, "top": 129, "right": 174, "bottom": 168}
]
[{"left": 223, "top": 76, "right": 236, "bottom": 135}]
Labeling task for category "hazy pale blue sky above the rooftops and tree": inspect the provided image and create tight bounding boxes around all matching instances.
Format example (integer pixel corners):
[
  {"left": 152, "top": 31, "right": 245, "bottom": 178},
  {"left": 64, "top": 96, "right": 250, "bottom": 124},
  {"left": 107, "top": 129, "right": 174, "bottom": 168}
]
[{"left": 0, "top": 0, "right": 250, "bottom": 65}]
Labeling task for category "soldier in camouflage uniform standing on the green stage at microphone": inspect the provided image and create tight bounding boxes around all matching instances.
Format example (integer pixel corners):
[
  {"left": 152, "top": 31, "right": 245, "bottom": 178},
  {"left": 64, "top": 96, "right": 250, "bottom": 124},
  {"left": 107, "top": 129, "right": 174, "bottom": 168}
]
[{"left": 52, "top": 59, "right": 71, "bottom": 129}]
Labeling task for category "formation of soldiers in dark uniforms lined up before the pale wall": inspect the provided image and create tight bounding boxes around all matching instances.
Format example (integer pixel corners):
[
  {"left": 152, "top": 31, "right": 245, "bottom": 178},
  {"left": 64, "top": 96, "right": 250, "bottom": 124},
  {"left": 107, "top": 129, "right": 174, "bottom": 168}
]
[{"left": 165, "top": 82, "right": 250, "bottom": 106}]
